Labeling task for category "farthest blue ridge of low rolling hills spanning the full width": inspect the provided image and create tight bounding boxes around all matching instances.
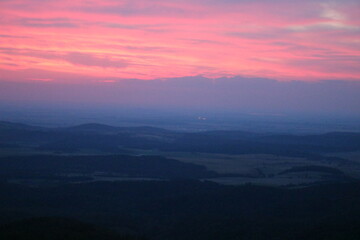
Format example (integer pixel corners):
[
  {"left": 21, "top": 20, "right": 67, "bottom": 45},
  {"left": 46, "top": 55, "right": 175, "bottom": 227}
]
[{"left": 0, "top": 122, "right": 360, "bottom": 156}]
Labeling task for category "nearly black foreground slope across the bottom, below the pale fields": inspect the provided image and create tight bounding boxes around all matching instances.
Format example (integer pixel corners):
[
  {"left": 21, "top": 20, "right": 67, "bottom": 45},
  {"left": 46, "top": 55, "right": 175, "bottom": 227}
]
[{"left": 0, "top": 180, "right": 360, "bottom": 240}]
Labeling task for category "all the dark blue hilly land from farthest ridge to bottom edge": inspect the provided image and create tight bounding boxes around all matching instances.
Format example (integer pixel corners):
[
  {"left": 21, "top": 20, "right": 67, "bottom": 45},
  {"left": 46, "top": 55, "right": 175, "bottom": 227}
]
[{"left": 0, "top": 122, "right": 360, "bottom": 240}]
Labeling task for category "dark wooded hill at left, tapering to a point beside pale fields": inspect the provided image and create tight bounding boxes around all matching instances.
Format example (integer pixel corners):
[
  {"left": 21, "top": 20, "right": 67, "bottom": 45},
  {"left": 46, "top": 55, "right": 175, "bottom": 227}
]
[{"left": 0, "top": 155, "right": 218, "bottom": 181}]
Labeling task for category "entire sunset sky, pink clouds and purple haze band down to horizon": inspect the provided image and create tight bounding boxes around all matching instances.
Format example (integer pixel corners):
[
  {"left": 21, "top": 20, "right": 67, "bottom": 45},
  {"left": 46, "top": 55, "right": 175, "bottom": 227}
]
[{"left": 0, "top": 0, "right": 360, "bottom": 116}]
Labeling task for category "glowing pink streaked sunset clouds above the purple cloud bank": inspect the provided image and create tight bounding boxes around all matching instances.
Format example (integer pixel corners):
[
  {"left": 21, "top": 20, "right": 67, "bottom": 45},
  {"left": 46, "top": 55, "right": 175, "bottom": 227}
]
[{"left": 0, "top": 0, "right": 360, "bottom": 84}]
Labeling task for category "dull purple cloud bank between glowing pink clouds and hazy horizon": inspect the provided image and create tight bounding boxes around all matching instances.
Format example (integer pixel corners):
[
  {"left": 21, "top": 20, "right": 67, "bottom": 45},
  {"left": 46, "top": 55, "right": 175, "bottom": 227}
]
[{"left": 0, "top": 76, "right": 360, "bottom": 120}]
